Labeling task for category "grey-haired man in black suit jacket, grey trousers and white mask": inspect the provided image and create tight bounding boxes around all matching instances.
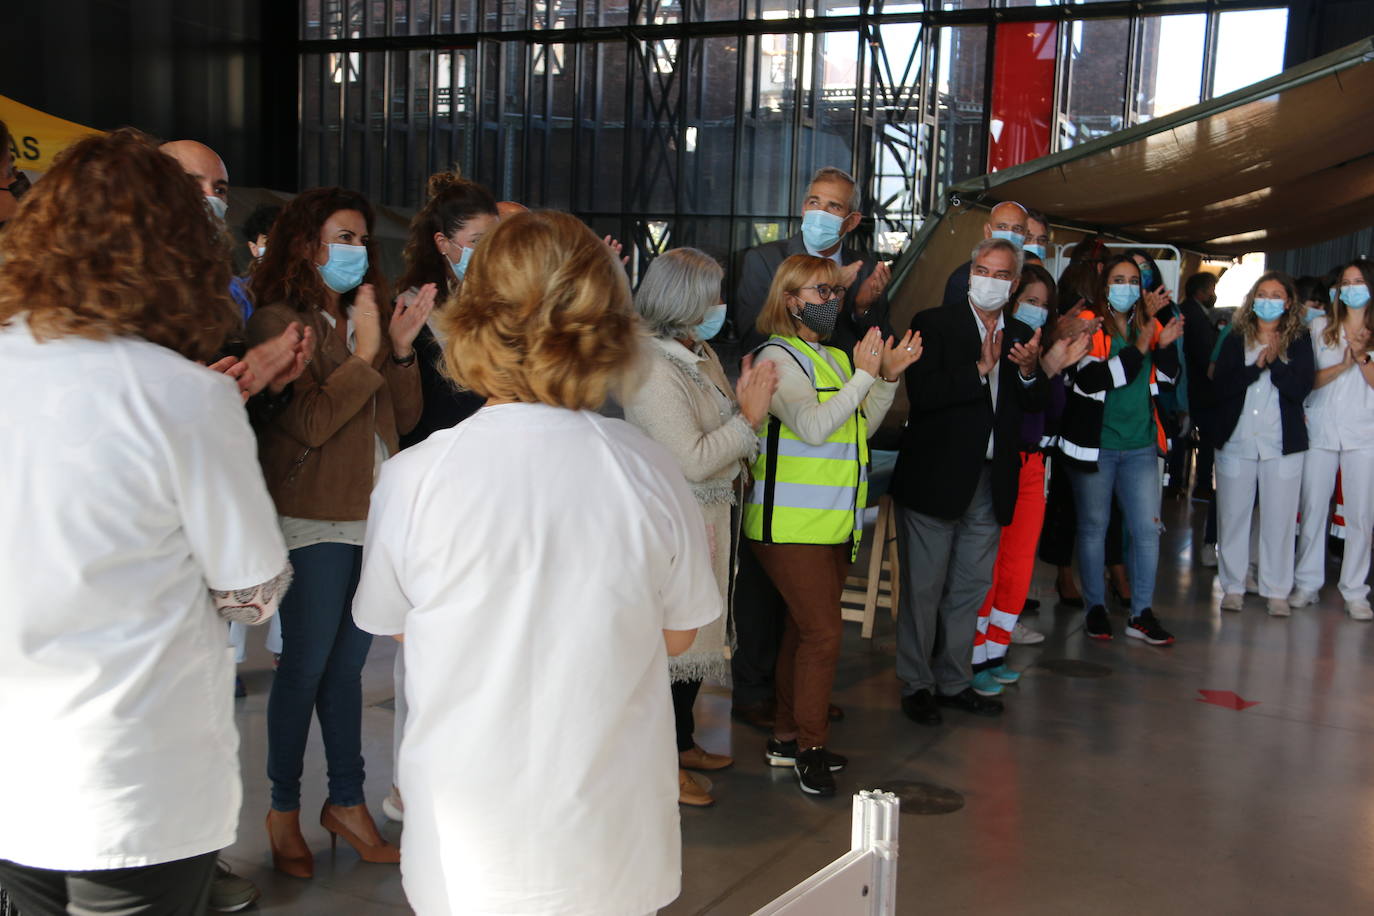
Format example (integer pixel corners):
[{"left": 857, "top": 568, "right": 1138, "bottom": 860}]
[{"left": 890, "top": 239, "right": 1050, "bottom": 725}]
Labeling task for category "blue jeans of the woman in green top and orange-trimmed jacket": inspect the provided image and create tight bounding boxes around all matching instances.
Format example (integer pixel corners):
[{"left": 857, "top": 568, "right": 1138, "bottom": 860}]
[{"left": 1069, "top": 445, "right": 1160, "bottom": 617}]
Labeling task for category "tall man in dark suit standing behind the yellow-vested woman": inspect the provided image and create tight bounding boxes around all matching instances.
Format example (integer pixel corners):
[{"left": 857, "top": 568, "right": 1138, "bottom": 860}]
[{"left": 735, "top": 168, "right": 892, "bottom": 353}]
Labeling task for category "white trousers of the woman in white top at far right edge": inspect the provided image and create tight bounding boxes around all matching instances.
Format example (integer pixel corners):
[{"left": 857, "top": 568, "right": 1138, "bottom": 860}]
[{"left": 1297, "top": 449, "right": 1374, "bottom": 602}]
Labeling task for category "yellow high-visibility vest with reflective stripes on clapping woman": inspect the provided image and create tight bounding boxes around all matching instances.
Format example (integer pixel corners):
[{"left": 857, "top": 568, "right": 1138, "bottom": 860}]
[{"left": 743, "top": 335, "right": 868, "bottom": 556}]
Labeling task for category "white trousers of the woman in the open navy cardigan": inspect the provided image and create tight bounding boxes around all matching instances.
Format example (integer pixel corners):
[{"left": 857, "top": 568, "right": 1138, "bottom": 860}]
[{"left": 1216, "top": 452, "right": 1304, "bottom": 597}]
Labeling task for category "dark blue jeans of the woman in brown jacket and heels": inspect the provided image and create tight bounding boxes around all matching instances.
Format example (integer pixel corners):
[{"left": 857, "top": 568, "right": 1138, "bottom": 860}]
[{"left": 267, "top": 544, "right": 372, "bottom": 812}]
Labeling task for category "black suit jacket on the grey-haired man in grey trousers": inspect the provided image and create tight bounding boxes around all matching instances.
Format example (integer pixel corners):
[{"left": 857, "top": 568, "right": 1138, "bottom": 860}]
[{"left": 890, "top": 304, "right": 1050, "bottom": 525}]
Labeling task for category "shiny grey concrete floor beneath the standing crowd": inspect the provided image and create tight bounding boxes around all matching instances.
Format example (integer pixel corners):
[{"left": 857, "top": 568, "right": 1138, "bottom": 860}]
[{"left": 225, "top": 501, "right": 1374, "bottom": 916}]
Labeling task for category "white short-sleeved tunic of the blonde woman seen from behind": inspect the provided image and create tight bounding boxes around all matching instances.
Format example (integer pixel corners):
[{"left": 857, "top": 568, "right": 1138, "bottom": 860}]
[{"left": 353, "top": 404, "right": 723, "bottom": 916}]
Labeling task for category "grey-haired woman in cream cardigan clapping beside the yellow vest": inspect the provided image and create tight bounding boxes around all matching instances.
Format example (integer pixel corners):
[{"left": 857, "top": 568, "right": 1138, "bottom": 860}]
[{"left": 625, "top": 249, "right": 778, "bottom": 806}]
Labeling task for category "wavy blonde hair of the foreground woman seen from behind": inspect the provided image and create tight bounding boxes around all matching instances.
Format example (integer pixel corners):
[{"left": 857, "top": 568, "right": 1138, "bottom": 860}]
[{"left": 438, "top": 210, "right": 644, "bottom": 409}]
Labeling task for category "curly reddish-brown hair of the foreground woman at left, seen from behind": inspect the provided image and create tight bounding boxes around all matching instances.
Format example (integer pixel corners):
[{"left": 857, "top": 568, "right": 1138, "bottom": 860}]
[{"left": 0, "top": 128, "right": 242, "bottom": 360}]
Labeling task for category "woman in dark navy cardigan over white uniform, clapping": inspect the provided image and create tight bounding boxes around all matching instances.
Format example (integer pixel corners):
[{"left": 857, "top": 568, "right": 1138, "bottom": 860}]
[{"left": 1208, "top": 271, "right": 1314, "bottom": 617}]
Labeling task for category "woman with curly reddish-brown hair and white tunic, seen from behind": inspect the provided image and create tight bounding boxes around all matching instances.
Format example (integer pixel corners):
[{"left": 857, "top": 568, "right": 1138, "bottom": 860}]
[{"left": 0, "top": 129, "right": 290, "bottom": 913}]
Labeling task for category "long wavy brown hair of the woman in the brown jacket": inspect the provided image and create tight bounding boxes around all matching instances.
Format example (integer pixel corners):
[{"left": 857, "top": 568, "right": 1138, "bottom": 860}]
[{"left": 249, "top": 188, "right": 386, "bottom": 321}]
